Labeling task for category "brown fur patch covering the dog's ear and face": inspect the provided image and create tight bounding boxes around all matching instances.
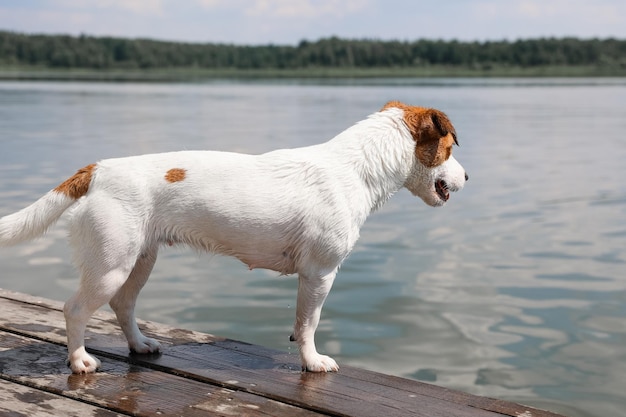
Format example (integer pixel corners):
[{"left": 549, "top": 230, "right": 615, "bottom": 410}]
[{"left": 381, "top": 101, "right": 458, "bottom": 168}]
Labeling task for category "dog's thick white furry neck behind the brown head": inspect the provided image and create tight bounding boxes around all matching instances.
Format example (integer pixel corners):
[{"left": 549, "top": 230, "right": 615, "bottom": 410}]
[{"left": 329, "top": 112, "right": 415, "bottom": 214}]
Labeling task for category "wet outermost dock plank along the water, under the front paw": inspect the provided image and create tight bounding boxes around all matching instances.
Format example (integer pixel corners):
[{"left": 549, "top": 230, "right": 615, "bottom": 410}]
[{"left": 0, "top": 291, "right": 558, "bottom": 417}]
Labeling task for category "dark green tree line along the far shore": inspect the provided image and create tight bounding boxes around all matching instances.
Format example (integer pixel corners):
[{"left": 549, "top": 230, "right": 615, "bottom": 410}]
[{"left": 0, "top": 31, "right": 626, "bottom": 69}]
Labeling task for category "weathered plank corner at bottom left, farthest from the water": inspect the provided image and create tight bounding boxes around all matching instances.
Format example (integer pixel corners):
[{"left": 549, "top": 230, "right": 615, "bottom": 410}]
[{"left": 0, "top": 379, "right": 122, "bottom": 417}]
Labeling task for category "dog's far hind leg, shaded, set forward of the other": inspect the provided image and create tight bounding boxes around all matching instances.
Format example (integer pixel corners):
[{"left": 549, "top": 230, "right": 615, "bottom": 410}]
[{"left": 109, "top": 244, "right": 161, "bottom": 353}]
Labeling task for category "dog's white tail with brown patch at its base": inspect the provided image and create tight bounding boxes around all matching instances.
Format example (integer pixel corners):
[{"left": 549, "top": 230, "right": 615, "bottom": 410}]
[{"left": 0, "top": 164, "right": 96, "bottom": 246}]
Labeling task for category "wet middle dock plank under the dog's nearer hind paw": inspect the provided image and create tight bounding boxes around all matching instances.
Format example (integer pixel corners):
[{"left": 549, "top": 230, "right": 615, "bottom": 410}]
[{"left": 0, "top": 331, "right": 326, "bottom": 417}]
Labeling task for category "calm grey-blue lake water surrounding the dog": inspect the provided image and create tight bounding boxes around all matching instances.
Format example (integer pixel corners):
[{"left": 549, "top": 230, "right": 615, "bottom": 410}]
[{"left": 0, "top": 79, "right": 626, "bottom": 417}]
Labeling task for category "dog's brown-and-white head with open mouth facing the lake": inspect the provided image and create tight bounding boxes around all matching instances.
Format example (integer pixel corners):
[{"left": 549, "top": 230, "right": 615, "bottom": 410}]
[{"left": 381, "top": 101, "right": 468, "bottom": 207}]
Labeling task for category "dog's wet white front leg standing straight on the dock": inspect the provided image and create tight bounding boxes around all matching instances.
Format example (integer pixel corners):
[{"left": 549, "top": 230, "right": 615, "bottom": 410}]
[{"left": 291, "top": 270, "right": 339, "bottom": 372}]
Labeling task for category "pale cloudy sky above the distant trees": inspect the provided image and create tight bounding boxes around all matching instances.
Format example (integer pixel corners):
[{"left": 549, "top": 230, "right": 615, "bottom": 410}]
[{"left": 0, "top": 0, "right": 626, "bottom": 45}]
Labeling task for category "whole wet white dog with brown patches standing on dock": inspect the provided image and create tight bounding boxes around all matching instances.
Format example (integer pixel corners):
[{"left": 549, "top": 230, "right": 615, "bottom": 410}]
[{"left": 0, "top": 102, "right": 467, "bottom": 373}]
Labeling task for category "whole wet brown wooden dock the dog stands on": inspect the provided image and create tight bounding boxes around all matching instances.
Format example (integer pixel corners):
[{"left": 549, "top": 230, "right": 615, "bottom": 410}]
[{"left": 0, "top": 289, "right": 560, "bottom": 417}]
